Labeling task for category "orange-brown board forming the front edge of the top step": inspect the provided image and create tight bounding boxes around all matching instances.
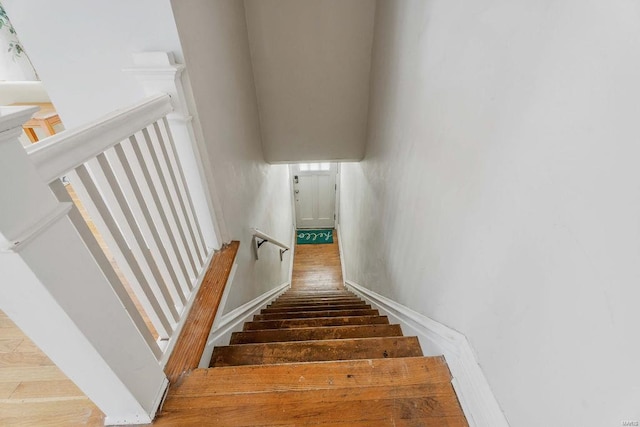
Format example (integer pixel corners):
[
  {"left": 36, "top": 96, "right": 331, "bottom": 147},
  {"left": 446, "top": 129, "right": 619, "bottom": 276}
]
[{"left": 171, "top": 356, "right": 451, "bottom": 397}]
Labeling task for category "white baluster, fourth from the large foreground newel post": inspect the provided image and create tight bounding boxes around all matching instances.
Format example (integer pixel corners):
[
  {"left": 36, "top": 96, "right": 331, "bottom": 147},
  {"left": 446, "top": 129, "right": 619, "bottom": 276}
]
[{"left": 114, "top": 144, "right": 189, "bottom": 305}]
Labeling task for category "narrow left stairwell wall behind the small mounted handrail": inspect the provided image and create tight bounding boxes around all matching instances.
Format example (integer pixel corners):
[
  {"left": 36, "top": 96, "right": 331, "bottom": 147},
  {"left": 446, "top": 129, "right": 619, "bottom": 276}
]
[{"left": 172, "top": 0, "right": 293, "bottom": 312}]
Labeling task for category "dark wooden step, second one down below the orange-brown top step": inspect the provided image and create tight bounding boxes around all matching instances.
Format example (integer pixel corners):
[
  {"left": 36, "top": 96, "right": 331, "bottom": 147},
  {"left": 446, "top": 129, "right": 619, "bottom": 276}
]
[{"left": 231, "top": 325, "right": 402, "bottom": 345}]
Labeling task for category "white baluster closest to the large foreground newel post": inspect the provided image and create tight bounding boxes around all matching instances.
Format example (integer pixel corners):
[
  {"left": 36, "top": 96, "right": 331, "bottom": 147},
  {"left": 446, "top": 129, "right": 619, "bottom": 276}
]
[{"left": 49, "top": 180, "right": 162, "bottom": 360}]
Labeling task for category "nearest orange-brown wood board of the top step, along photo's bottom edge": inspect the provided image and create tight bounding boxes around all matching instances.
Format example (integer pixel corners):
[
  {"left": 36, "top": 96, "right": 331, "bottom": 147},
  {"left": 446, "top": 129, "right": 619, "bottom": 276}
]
[{"left": 156, "top": 383, "right": 466, "bottom": 426}]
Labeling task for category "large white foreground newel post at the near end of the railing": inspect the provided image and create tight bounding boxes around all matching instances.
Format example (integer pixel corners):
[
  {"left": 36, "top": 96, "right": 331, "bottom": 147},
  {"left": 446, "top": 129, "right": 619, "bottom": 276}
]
[{"left": 0, "top": 107, "right": 168, "bottom": 424}]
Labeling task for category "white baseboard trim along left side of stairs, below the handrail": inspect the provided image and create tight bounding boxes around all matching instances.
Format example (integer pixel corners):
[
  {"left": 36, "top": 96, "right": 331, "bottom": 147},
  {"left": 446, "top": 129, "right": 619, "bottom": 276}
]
[{"left": 198, "top": 282, "right": 290, "bottom": 368}]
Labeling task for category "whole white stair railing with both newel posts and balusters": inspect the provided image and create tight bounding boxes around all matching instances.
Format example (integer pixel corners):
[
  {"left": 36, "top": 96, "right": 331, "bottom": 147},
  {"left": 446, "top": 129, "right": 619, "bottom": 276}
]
[{"left": 0, "top": 52, "right": 219, "bottom": 425}]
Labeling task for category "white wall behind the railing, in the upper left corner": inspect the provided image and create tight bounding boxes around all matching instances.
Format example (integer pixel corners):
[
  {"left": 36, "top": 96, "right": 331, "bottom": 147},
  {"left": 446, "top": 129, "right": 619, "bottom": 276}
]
[{"left": 2, "top": 0, "right": 183, "bottom": 129}]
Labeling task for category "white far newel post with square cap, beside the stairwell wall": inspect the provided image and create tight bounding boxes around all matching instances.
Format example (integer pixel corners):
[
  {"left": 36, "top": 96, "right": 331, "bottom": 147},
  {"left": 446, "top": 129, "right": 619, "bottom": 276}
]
[{"left": 124, "top": 52, "right": 228, "bottom": 249}]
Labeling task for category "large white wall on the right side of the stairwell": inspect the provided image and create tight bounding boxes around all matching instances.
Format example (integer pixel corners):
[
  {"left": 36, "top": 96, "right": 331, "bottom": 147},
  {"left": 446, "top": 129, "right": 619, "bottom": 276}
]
[{"left": 340, "top": 0, "right": 640, "bottom": 427}]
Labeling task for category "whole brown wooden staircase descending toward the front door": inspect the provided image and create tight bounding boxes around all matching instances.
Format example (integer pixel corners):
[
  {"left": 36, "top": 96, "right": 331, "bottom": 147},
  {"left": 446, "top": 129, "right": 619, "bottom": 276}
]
[{"left": 155, "top": 286, "right": 468, "bottom": 427}]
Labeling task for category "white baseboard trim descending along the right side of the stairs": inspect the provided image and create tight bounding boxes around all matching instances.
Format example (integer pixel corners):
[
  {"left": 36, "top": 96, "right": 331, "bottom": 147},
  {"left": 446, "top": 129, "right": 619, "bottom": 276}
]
[{"left": 345, "top": 280, "right": 509, "bottom": 427}]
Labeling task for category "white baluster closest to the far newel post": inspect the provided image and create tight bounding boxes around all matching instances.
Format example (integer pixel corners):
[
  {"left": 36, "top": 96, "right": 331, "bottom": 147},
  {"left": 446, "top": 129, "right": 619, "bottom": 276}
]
[{"left": 153, "top": 121, "right": 205, "bottom": 265}]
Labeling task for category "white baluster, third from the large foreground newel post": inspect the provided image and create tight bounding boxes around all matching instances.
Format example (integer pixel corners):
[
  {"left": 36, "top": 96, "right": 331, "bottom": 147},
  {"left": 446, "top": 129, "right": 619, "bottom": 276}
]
[{"left": 96, "top": 153, "right": 186, "bottom": 314}]
